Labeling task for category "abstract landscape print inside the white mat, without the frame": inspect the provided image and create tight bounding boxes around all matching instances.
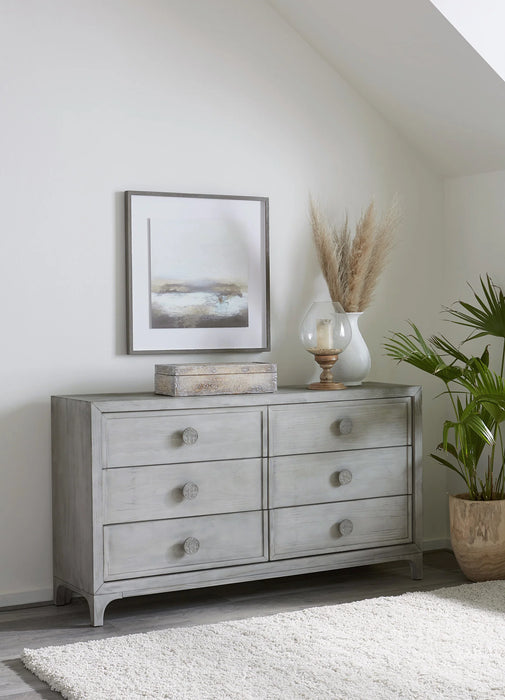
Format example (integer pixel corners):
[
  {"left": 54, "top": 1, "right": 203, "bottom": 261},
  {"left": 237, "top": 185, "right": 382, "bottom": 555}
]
[{"left": 150, "top": 219, "right": 249, "bottom": 328}]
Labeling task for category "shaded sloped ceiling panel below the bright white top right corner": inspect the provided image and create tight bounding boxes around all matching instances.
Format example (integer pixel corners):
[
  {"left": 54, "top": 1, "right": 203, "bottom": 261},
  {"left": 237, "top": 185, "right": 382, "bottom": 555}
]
[{"left": 268, "top": 0, "right": 505, "bottom": 176}]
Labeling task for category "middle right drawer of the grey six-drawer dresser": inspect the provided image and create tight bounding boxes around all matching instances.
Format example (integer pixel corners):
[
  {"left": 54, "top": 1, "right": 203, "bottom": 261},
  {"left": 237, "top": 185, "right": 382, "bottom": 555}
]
[{"left": 269, "top": 447, "right": 411, "bottom": 508}]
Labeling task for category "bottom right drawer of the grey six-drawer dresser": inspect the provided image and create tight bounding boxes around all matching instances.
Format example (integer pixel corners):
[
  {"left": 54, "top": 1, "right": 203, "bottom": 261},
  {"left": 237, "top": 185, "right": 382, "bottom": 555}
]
[{"left": 270, "top": 496, "right": 411, "bottom": 559}]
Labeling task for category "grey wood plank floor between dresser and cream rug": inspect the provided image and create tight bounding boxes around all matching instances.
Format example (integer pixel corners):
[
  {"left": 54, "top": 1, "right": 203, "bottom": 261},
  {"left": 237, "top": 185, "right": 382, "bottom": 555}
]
[{"left": 0, "top": 551, "right": 468, "bottom": 700}]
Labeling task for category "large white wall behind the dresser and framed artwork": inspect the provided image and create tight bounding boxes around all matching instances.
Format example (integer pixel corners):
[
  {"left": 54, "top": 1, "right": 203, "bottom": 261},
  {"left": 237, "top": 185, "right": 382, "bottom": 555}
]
[{"left": 0, "top": 0, "right": 446, "bottom": 604}]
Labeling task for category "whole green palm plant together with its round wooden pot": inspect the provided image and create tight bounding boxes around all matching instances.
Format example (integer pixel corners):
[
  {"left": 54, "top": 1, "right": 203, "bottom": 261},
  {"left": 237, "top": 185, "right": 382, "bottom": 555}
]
[{"left": 385, "top": 275, "right": 505, "bottom": 581}]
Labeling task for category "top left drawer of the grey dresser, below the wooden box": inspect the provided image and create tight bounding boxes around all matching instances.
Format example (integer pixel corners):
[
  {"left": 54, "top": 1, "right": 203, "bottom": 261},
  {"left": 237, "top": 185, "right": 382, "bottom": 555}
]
[{"left": 102, "top": 408, "right": 263, "bottom": 467}]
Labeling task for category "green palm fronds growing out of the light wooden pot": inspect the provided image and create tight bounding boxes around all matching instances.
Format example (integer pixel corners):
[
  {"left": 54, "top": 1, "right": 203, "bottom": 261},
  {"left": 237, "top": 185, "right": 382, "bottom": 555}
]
[{"left": 384, "top": 275, "right": 505, "bottom": 500}]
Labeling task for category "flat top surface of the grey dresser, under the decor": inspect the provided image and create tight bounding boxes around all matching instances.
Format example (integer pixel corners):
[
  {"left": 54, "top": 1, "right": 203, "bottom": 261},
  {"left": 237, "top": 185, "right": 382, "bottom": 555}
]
[{"left": 53, "top": 382, "right": 421, "bottom": 412}]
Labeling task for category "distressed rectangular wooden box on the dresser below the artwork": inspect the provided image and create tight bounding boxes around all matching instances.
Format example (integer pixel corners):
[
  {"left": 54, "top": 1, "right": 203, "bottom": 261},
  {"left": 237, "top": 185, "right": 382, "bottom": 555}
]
[{"left": 154, "top": 362, "right": 277, "bottom": 396}]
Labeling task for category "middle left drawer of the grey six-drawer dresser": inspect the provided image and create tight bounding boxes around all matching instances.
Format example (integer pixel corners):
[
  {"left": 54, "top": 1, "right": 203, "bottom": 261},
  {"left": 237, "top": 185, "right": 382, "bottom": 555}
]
[{"left": 103, "top": 459, "right": 263, "bottom": 523}]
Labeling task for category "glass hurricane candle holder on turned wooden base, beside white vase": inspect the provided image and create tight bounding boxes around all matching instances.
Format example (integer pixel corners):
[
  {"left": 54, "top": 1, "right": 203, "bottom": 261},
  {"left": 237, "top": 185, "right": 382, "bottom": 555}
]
[{"left": 300, "top": 301, "right": 352, "bottom": 391}]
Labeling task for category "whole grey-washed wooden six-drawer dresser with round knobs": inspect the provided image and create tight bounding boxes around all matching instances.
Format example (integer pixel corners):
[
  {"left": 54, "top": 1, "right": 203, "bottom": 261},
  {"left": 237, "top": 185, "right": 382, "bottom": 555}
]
[{"left": 52, "top": 383, "right": 422, "bottom": 626}]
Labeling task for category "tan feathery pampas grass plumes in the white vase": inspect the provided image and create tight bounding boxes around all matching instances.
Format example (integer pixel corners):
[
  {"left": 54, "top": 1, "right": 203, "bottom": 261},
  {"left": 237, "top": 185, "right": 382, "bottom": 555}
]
[{"left": 310, "top": 198, "right": 400, "bottom": 312}]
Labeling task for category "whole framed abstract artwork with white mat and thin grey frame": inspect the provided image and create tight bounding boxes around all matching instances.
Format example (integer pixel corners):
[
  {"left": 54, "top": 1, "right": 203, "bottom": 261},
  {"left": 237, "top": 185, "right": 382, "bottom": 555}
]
[{"left": 125, "top": 191, "right": 270, "bottom": 354}]
